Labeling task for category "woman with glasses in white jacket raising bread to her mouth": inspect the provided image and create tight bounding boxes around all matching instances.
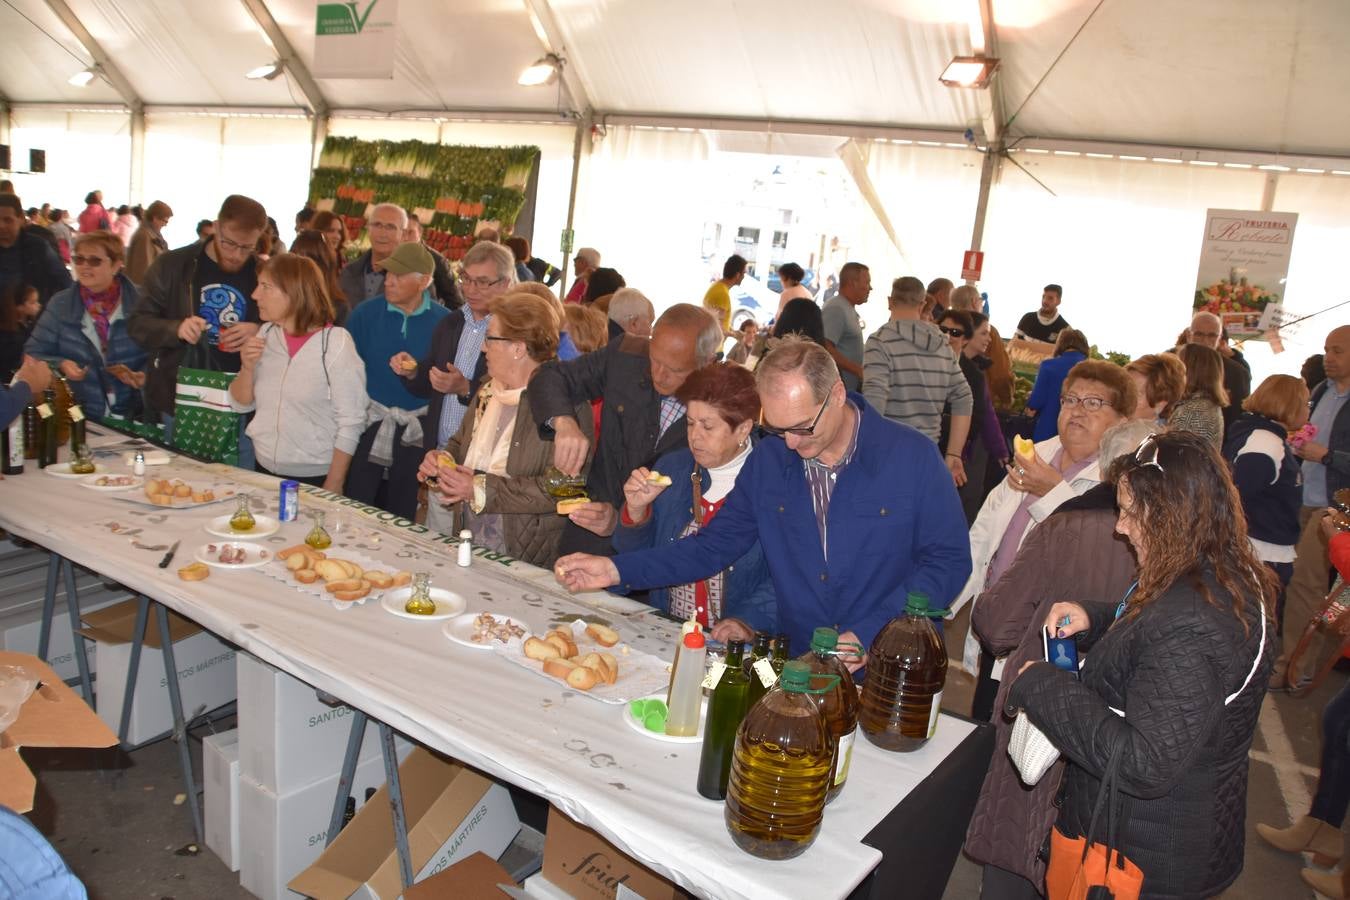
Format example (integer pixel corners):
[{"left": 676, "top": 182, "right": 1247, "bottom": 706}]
[{"left": 956, "top": 359, "right": 1135, "bottom": 721}]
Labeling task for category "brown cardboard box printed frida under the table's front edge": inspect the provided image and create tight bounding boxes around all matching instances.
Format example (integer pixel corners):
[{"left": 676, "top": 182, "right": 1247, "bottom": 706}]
[{"left": 543, "top": 807, "right": 686, "bottom": 900}]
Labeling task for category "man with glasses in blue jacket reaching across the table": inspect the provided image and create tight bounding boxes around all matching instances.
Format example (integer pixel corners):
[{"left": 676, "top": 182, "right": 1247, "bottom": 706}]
[{"left": 555, "top": 339, "right": 971, "bottom": 671}]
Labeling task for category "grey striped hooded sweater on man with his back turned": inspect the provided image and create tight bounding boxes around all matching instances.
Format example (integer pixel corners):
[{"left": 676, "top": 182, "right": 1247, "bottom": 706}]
[{"left": 863, "top": 320, "right": 975, "bottom": 441}]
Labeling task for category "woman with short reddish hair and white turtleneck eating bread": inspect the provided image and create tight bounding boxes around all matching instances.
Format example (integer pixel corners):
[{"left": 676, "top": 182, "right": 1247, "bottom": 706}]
[{"left": 614, "top": 363, "right": 778, "bottom": 641}]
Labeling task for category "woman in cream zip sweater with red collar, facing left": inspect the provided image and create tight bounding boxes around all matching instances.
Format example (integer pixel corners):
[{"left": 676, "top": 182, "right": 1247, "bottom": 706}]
[{"left": 230, "top": 254, "right": 369, "bottom": 494}]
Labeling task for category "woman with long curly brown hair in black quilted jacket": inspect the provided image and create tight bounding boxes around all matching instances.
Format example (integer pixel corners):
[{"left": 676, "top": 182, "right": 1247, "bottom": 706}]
[{"left": 1007, "top": 432, "right": 1276, "bottom": 900}]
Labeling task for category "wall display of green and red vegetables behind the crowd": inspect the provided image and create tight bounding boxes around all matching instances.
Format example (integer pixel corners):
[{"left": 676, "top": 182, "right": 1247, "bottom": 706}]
[{"left": 309, "top": 136, "right": 540, "bottom": 259}]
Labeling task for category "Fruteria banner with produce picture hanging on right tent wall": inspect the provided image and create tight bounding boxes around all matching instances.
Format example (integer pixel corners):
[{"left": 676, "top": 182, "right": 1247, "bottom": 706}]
[{"left": 1193, "top": 209, "right": 1299, "bottom": 340}]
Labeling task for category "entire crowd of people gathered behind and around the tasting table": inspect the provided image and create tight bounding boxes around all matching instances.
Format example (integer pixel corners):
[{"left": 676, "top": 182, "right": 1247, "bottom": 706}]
[{"left": 0, "top": 179, "right": 1350, "bottom": 897}]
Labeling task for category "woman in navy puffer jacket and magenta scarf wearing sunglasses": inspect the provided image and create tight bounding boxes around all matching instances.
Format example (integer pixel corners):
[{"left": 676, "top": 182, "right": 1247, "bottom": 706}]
[{"left": 24, "top": 231, "right": 146, "bottom": 418}]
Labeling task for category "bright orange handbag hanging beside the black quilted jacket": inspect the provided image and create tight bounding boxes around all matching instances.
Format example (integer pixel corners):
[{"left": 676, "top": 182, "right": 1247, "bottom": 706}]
[{"left": 1045, "top": 742, "right": 1143, "bottom": 900}]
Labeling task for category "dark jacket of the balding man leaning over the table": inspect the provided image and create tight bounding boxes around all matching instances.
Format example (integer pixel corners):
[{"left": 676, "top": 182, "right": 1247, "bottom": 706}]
[{"left": 529, "top": 335, "right": 689, "bottom": 555}]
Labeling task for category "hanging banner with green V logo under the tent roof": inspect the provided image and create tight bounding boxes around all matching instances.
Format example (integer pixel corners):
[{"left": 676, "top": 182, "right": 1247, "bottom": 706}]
[{"left": 313, "top": 0, "right": 398, "bottom": 78}]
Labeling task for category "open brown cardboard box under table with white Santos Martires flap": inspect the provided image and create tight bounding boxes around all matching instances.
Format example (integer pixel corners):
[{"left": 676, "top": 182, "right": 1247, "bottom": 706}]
[{"left": 290, "top": 748, "right": 520, "bottom": 900}]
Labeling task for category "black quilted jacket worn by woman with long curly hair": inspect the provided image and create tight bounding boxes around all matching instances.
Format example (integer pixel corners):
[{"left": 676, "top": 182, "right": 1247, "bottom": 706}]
[{"left": 1007, "top": 575, "right": 1276, "bottom": 899}]
